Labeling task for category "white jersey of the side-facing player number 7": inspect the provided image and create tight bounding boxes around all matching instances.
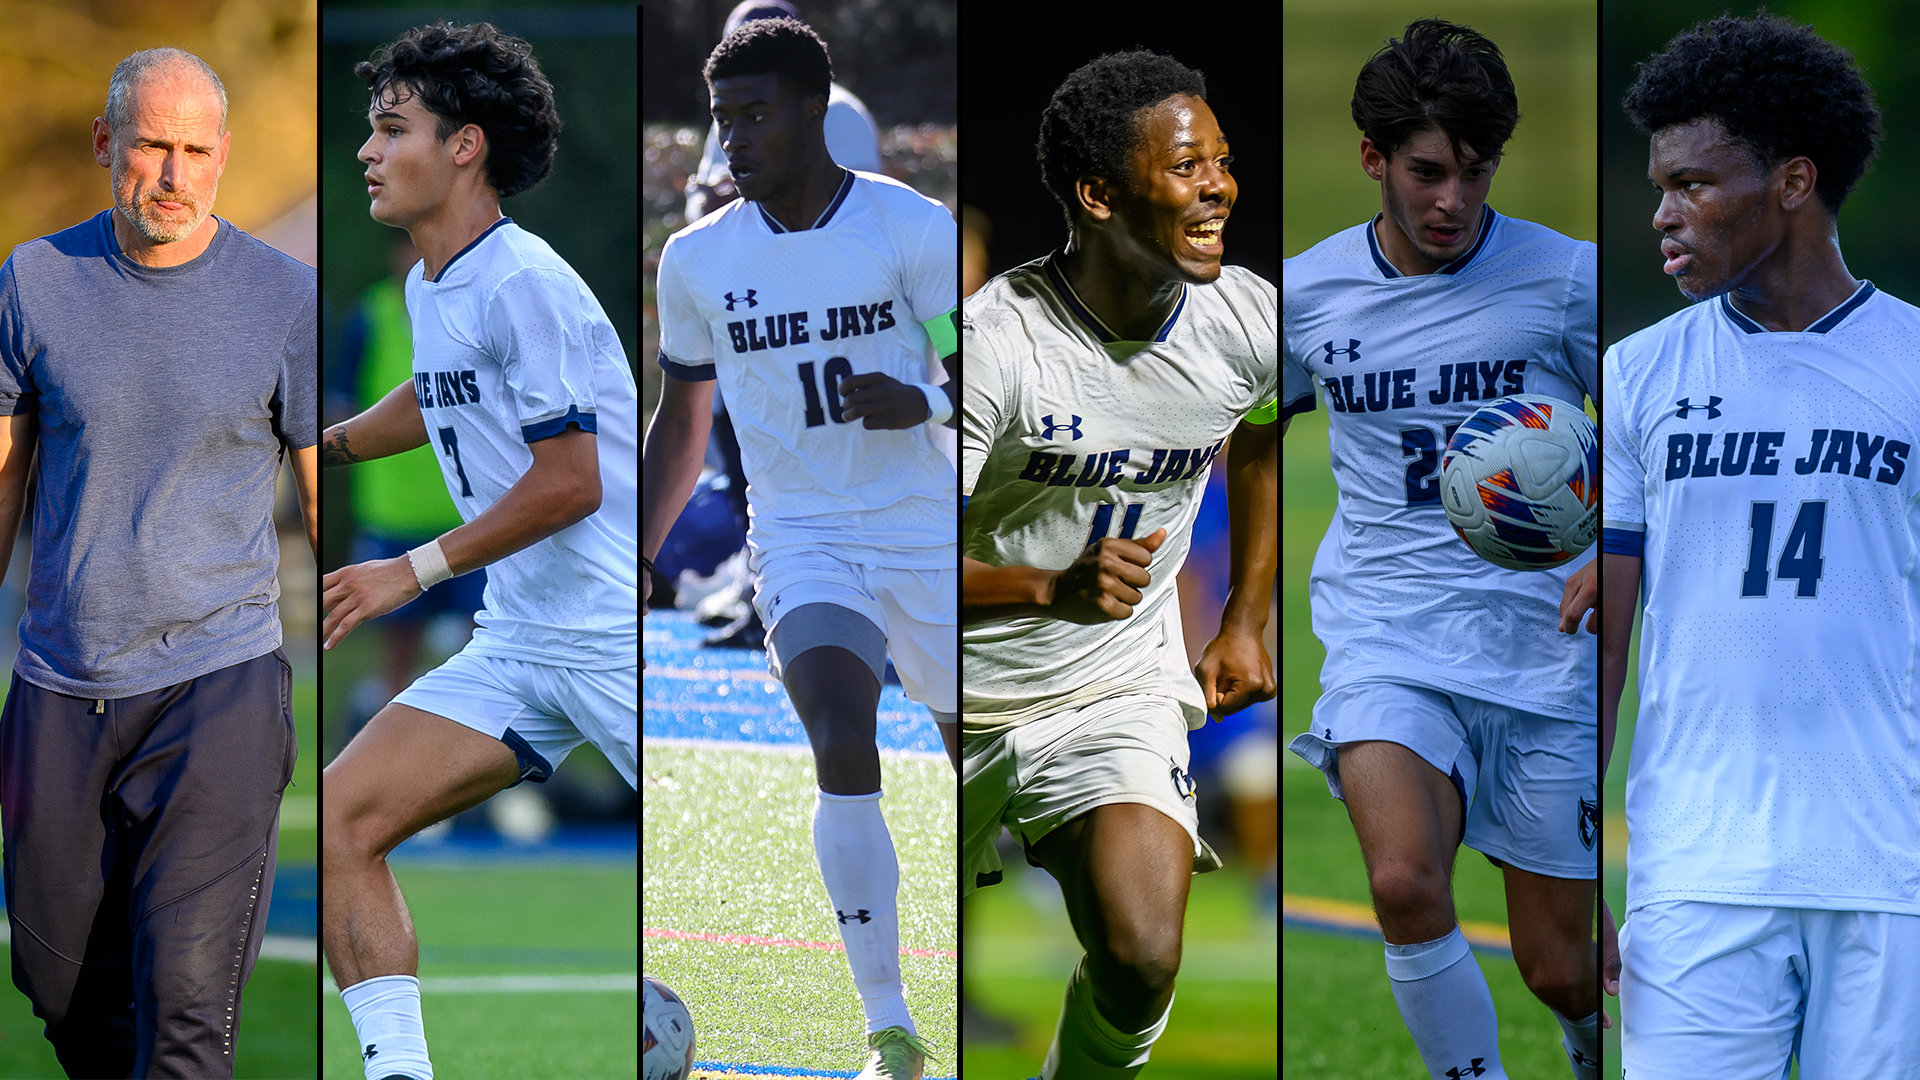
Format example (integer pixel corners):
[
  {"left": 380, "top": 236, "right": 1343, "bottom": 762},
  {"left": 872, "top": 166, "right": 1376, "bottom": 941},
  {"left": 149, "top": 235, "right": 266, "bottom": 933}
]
[{"left": 407, "top": 217, "right": 639, "bottom": 669}]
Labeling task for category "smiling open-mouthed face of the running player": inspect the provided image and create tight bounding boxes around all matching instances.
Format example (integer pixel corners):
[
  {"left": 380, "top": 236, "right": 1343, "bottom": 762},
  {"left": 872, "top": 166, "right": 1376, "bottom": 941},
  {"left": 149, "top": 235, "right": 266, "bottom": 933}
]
[{"left": 1112, "top": 94, "right": 1240, "bottom": 284}]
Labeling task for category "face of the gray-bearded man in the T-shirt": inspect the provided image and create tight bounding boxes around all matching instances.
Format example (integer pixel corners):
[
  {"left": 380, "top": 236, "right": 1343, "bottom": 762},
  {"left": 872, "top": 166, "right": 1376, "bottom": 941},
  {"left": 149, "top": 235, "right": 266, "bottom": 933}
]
[{"left": 108, "top": 79, "right": 227, "bottom": 244}]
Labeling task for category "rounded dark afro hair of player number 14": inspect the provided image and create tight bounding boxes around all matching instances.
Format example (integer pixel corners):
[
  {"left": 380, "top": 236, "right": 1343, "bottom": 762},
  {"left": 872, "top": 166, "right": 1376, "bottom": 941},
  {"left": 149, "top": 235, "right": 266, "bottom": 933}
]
[{"left": 1620, "top": 10, "right": 1880, "bottom": 213}]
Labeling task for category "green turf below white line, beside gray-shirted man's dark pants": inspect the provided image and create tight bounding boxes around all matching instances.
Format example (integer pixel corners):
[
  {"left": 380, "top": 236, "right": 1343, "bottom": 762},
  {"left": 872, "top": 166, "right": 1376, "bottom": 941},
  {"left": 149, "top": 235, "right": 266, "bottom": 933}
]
[{"left": 0, "top": 947, "right": 315, "bottom": 1080}]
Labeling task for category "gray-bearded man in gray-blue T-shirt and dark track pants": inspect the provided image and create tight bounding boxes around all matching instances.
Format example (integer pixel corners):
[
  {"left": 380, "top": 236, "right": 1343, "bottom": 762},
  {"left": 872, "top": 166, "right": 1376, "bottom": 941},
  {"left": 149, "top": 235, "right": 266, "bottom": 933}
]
[{"left": 0, "top": 48, "right": 319, "bottom": 1076}]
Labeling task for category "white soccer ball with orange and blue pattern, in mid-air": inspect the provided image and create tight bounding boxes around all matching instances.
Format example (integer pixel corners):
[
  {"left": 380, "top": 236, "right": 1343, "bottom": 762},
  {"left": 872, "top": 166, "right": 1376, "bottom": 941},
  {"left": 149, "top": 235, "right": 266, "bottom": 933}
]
[{"left": 1440, "top": 394, "right": 1599, "bottom": 571}]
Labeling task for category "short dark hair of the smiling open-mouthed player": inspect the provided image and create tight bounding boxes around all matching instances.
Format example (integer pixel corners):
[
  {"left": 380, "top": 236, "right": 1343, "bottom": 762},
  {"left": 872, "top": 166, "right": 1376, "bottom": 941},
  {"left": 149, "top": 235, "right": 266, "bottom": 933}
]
[{"left": 1037, "top": 50, "right": 1206, "bottom": 227}]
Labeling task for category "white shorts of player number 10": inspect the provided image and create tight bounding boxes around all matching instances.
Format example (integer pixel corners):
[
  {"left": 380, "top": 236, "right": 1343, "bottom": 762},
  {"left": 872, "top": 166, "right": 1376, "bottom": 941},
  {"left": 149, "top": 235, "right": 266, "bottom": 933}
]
[{"left": 753, "top": 552, "right": 960, "bottom": 713}]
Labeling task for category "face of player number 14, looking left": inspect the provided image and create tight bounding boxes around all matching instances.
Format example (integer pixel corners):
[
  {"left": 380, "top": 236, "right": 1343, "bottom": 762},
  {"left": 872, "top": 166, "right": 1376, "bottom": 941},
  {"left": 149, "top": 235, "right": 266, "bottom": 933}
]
[{"left": 1647, "top": 119, "right": 1786, "bottom": 300}]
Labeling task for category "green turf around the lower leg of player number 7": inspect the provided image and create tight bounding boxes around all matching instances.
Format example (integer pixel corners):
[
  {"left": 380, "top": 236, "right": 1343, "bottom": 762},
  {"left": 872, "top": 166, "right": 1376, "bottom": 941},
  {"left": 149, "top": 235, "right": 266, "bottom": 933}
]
[{"left": 324, "top": 863, "right": 639, "bottom": 1080}]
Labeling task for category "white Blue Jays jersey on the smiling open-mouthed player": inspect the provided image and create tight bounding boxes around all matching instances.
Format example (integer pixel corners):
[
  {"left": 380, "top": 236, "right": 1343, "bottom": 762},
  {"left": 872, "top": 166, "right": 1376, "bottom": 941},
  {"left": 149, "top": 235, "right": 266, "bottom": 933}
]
[{"left": 960, "top": 256, "right": 1277, "bottom": 732}]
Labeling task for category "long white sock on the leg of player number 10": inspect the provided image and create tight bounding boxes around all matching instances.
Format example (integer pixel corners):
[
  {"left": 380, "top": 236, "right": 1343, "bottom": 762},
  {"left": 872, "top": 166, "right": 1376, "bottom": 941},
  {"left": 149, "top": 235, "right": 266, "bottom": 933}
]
[{"left": 814, "top": 792, "right": 920, "bottom": 1034}]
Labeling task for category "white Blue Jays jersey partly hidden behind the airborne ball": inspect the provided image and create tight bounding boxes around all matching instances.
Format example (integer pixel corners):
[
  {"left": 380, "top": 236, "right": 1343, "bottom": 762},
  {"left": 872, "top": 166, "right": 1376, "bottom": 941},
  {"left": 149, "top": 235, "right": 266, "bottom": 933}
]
[{"left": 1283, "top": 208, "right": 1597, "bottom": 721}]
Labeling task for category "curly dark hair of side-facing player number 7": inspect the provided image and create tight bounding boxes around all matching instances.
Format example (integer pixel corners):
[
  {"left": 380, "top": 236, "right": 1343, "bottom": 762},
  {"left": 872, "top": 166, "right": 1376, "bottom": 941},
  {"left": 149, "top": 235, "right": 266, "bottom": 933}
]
[{"left": 353, "top": 23, "right": 561, "bottom": 198}]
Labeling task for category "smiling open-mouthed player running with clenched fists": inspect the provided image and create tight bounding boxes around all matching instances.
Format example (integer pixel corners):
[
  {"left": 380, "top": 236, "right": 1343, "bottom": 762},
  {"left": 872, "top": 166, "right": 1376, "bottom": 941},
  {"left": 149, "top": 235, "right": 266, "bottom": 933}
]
[{"left": 960, "top": 52, "right": 1279, "bottom": 1080}]
